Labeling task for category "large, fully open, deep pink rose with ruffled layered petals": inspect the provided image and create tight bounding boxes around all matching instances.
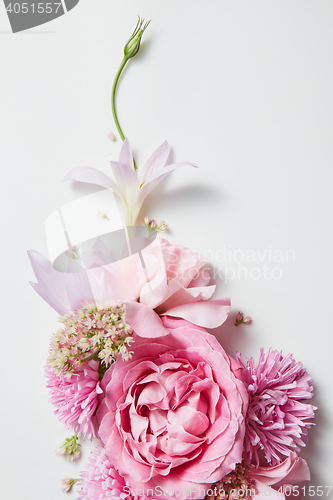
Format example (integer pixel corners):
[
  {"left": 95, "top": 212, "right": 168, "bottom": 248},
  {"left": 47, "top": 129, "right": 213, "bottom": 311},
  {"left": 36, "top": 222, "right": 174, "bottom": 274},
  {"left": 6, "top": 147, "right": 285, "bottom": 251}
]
[{"left": 98, "top": 317, "right": 248, "bottom": 499}]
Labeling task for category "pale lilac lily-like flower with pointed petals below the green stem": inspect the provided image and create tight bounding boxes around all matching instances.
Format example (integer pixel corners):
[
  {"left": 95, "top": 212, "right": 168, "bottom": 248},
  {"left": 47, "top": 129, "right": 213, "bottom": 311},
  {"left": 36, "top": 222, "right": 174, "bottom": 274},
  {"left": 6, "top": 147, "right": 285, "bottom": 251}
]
[{"left": 62, "top": 139, "right": 197, "bottom": 226}]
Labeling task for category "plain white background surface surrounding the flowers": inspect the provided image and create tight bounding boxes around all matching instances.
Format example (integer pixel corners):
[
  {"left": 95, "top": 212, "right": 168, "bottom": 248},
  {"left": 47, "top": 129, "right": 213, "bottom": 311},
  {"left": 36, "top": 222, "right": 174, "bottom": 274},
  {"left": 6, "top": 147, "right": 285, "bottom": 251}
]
[{"left": 0, "top": 0, "right": 333, "bottom": 500}]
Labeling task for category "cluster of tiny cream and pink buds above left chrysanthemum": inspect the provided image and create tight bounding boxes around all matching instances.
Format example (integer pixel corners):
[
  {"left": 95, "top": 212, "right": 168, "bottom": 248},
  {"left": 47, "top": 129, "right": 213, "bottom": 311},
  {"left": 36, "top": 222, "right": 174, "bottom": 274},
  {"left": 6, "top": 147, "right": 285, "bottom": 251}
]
[{"left": 48, "top": 301, "right": 133, "bottom": 375}]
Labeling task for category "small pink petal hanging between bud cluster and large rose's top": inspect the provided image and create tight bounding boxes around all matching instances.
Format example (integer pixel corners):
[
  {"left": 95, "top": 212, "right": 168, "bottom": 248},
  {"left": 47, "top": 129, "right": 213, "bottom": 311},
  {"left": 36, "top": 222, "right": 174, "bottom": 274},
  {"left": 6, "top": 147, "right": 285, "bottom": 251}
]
[{"left": 125, "top": 302, "right": 169, "bottom": 338}]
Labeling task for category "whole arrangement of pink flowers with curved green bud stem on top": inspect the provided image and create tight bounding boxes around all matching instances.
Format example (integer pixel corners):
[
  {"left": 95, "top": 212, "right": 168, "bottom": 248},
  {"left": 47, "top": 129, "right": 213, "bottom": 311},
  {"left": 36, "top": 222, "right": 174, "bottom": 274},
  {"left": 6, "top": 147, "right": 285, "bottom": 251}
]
[{"left": 29, "top": 19, "right": 315, "bottom": 500}]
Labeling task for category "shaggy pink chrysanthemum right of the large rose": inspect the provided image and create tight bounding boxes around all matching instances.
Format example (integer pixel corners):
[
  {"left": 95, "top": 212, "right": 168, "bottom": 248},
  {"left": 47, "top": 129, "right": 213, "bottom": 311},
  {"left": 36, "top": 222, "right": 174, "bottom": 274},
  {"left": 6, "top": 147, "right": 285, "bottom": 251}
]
[{"left": 237, "top": 348, "right": 316, "bottom": 465}]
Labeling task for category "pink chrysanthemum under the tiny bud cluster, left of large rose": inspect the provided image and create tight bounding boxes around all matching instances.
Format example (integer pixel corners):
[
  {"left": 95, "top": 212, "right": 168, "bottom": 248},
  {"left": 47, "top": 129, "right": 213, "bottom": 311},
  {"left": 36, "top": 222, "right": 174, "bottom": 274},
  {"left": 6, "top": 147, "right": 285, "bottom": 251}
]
[{"left": 45, "top": 360, "right": 103, "bottom": 439}]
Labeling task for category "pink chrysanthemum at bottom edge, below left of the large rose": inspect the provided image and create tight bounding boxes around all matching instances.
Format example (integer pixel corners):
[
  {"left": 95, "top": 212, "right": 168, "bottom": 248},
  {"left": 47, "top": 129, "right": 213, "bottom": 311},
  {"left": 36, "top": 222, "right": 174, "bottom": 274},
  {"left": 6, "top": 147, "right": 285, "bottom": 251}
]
[{"left": 77, "top": 444, "right": 141, "bottom": 500}]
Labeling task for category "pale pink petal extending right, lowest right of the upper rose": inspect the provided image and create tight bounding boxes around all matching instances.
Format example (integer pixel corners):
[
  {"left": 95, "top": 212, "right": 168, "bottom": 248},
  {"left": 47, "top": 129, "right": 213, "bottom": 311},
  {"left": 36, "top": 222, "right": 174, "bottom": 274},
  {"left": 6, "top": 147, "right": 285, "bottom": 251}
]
[{"left": 163, "top": 298, "right": 231, "bottom": 328}]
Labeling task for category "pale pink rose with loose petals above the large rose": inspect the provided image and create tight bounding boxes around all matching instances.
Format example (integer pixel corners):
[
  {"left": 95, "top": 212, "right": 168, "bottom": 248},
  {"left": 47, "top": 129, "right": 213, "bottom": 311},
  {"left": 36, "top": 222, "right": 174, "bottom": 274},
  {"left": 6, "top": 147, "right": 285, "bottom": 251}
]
[{"left": 88, "top": 238, "right": 230, "bottom": 337}]
